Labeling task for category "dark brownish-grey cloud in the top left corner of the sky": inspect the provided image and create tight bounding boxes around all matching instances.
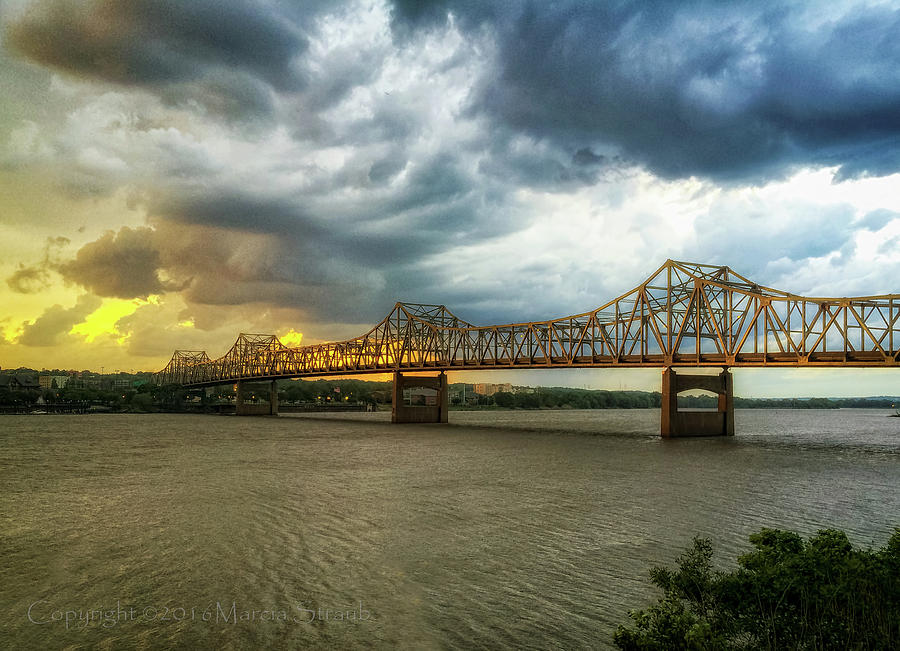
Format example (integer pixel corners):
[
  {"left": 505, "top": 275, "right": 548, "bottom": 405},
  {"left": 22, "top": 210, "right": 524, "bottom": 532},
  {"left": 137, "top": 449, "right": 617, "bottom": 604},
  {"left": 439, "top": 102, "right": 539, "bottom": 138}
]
[{"left": 9, "top": 0, "right": 308, "bottom": 115}]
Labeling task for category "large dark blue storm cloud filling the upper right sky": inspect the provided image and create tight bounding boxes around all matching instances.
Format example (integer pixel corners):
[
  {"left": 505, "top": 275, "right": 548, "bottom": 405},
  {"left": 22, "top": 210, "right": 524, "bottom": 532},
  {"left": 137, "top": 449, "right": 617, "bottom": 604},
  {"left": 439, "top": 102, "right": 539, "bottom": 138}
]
[{"left": 393, "top": 0, "right": 900, "bottom": 181}]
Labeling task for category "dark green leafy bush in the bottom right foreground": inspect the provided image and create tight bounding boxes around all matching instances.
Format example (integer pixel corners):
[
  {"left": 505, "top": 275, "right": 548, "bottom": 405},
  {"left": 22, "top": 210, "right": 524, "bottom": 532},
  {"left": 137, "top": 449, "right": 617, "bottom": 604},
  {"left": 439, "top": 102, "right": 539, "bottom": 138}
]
[{"left": 613, "top": 528, "right": 900, "bottom": 651}]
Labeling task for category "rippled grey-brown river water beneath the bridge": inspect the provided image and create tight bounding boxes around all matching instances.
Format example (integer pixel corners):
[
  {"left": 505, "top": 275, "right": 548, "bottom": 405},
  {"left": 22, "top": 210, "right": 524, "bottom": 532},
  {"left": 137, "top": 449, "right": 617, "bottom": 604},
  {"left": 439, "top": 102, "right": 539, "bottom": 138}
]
[{"left": 0, "top": 409, "right": 900, "bottom": 649}]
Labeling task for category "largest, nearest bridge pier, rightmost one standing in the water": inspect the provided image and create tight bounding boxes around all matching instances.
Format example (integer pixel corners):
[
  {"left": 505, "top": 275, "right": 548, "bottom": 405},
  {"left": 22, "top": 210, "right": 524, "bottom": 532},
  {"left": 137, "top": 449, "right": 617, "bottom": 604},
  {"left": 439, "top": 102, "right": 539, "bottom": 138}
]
[{"left": 659, "top": 367, "right": 734, "bottom": 438}]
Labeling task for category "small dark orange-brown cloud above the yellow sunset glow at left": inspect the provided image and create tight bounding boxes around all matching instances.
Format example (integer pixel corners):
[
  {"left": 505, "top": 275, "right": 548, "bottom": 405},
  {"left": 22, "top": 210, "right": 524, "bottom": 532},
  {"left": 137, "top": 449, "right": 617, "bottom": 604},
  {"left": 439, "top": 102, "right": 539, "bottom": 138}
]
[{"left": 57, "top": 226, "right": 175, "bottom": 298}]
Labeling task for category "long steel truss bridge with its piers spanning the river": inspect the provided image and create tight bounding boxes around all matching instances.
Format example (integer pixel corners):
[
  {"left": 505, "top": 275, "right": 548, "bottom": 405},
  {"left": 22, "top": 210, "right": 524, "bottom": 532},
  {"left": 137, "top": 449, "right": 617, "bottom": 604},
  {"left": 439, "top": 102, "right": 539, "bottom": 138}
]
[{"left": 153, "top": 260, "right": 900, "bottom": 436}]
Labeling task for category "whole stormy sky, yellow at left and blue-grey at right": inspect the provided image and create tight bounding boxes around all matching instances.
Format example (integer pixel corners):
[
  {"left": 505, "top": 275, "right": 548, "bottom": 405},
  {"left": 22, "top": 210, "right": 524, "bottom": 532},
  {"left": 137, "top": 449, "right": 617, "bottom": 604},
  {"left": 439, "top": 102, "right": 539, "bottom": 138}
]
[{"left": 0, "top": 0, "right": 900, "bottom": 395}]
